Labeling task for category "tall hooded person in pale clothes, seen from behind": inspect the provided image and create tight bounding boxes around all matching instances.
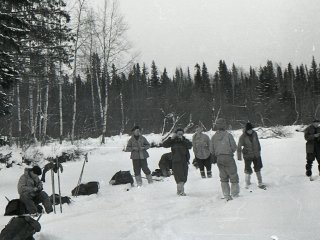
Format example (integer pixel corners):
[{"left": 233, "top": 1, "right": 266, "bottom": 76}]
[{"left": 210, "top": 118, "right": 240, "bottom": 201}]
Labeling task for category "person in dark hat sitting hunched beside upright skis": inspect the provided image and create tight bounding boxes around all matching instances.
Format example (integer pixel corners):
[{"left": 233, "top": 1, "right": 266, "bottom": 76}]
[{"left": 18, "top": 166, "right": 53, "bottom": 214}]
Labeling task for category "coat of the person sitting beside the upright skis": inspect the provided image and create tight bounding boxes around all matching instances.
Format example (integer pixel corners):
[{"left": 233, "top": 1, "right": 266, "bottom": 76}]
[{"left": 18, "top": 168, "right": 42, "bottom": 196}]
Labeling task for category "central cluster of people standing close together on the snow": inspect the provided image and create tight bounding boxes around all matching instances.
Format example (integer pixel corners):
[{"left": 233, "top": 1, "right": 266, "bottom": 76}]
[{"left": 126, "top": 118, "right": 265, "bottom": 201}]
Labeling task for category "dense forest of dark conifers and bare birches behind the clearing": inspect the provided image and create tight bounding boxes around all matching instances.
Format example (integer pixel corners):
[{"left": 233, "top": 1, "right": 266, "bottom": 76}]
[{"left": 0, "top": 0, "right": 320, "bottom": 144}]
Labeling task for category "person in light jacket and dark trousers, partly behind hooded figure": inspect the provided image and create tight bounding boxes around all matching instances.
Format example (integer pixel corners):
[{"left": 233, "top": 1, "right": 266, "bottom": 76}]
[{"left": 192, "top": 126, "right": 212, "bottom": 178}]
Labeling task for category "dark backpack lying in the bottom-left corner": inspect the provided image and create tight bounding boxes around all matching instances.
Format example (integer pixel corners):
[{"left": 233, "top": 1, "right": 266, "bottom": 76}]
[{"left": 0, "top": 216, "right": 41, "bottom": 240}]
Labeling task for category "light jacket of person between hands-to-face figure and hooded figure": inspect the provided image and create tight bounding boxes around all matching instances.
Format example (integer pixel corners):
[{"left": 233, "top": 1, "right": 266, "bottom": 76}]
[{"left": 192, "top": 133, "right": 210, "bottom": 159}]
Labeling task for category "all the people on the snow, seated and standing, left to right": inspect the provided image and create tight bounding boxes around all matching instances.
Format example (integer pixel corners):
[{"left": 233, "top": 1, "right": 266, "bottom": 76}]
[{"left": 14, "top": 118, "right": 320, "bottom": 214}]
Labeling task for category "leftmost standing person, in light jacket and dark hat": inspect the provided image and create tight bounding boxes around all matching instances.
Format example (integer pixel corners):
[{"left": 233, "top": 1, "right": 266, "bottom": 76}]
[{"left": 125, "top": 126, "right": 152, "bottom": 186}]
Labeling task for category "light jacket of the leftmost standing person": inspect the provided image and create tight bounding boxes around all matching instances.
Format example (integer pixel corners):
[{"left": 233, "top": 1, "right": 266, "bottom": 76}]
[{"left": 126, "top": 136, "right": 150, "bottom": 159}]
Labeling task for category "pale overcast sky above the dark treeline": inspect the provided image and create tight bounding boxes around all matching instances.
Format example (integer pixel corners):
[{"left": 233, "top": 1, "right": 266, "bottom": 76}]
[{"left": 88, "top": 0, "right": 320, "bottom": 73}]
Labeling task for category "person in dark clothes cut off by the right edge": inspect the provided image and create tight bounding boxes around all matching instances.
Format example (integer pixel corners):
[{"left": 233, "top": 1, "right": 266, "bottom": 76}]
[{"left": 304, "top": 119, "right": 320, "bottom": 177}]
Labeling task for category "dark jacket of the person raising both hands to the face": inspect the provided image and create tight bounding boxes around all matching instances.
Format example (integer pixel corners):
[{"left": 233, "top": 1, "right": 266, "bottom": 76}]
[{"left": 163, "top": 137, "right": 192, "bottom": 163}]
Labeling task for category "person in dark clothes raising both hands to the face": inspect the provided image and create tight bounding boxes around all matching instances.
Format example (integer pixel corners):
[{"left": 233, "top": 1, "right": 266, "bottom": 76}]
[{"left": 163, "top": 128, "right": 192, "bottom": 196}]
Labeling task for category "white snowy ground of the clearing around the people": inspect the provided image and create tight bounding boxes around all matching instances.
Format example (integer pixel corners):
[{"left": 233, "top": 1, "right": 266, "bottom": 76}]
[{"left": 0, "top": 127, "right": 320, "bottom": 240}]
